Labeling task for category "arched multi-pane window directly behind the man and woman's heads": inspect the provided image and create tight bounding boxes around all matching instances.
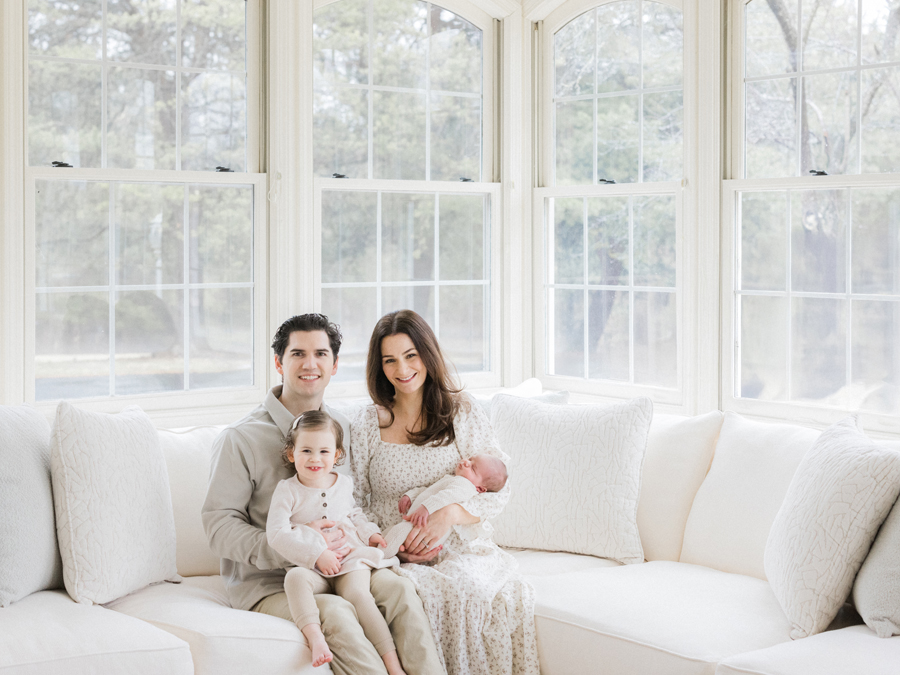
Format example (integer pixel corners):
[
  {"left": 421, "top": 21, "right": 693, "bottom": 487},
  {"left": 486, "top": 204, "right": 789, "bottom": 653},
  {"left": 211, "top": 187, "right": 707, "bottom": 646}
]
[{"left": 313, "top": 0, "right": 499, "bottom": 381}]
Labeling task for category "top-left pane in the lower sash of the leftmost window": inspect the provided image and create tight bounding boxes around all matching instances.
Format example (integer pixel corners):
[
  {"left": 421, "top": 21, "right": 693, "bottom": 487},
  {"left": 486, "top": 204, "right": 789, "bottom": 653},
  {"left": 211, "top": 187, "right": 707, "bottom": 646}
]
[{"left": 34, "top": 180, "right": 109, "bottom": 288}]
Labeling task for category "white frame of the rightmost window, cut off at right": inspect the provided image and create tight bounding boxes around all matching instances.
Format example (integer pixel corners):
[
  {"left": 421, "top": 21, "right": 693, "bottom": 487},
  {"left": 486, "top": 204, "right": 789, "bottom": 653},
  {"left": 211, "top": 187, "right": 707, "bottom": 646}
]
[{"left": 720, "top": 0, "right": 900, "bottom": 434}]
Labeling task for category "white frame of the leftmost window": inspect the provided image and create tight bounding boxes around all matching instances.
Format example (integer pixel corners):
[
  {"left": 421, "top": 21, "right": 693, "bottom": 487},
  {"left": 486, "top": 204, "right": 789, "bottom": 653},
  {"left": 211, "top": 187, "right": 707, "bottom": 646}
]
[{"left": 0, "top": 0, "right": 270, "bottom": 426}]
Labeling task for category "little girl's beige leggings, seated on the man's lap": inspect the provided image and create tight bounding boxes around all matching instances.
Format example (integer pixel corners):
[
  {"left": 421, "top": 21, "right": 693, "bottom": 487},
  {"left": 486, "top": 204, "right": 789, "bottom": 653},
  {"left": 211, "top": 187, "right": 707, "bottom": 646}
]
[{"left": 284, "top": 567, "right": 396, "bottom": 656}]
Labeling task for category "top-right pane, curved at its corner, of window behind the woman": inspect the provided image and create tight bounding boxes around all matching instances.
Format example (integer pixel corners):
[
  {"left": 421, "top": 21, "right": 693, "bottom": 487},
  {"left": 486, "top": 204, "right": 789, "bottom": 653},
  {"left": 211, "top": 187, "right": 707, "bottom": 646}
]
[{"left": 429, "top": 5, "right": 482, "bottom": 94}]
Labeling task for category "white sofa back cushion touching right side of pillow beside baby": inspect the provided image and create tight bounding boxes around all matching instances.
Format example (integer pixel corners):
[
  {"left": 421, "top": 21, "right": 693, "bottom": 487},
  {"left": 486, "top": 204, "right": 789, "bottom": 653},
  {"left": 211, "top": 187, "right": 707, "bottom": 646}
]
[{"left": 638, "top": 410, "right": 723, "bottom": 561}]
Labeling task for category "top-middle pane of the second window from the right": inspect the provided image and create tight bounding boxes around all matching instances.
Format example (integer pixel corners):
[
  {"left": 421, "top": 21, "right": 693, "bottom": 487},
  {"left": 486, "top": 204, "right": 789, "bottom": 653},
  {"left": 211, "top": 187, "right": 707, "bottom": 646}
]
[{"left": 596, "top": 0, "right": 649, "bottom": 93}]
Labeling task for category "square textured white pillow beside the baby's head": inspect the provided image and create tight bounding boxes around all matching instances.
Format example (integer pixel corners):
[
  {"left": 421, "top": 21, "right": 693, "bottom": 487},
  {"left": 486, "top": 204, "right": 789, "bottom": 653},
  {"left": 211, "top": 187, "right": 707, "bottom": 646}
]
[{"left": 491, "top": 395, "right": 653, "bottom": 563}]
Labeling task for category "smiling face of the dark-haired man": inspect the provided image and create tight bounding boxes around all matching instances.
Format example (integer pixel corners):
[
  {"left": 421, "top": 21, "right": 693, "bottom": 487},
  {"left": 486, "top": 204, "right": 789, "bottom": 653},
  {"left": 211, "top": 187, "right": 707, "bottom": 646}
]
[{"left": 275, "top": 330, "right": 337, "bottom": 397}]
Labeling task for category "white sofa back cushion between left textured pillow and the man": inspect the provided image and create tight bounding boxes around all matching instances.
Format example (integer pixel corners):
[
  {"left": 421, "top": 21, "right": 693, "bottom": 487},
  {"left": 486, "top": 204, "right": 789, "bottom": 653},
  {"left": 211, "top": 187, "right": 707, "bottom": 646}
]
[{"left": 159, "top": 426, "right": 225, "bottom": 577}]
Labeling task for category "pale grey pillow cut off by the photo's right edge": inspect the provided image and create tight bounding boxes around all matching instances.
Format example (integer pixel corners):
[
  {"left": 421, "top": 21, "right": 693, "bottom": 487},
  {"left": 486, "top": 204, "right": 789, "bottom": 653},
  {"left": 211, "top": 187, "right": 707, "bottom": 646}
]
[{"left": 853, "top": 500, "right": 900, "bottom": 637}]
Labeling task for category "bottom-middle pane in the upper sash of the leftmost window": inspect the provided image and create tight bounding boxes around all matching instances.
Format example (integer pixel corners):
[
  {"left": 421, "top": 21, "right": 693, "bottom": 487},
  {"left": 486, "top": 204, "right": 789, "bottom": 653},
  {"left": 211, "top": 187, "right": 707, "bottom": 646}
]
[{"left": 107, "top": 68, "right": 175, "bottom": 169}]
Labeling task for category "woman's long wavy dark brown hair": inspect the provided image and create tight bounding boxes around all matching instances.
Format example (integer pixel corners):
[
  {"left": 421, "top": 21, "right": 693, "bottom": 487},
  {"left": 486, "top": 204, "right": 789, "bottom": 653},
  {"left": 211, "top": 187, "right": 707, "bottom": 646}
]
[{"left": 366, "top": 309, "right": 461, "bottom": 445}]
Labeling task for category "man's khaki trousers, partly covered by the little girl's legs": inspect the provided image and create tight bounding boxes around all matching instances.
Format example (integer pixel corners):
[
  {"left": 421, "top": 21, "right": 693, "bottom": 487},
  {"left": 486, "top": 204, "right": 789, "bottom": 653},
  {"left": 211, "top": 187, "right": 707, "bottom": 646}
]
[{"left": 252, "top": 569, "right": 444, "bottom": 675}]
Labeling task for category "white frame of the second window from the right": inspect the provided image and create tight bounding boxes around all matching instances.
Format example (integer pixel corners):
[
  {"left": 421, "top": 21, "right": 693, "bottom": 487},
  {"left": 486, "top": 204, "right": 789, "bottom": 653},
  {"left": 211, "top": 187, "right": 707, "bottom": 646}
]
[{"left": 532, "top": 0, "right": 718, "bottom": 413}]
